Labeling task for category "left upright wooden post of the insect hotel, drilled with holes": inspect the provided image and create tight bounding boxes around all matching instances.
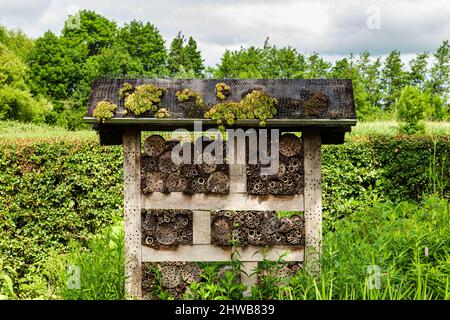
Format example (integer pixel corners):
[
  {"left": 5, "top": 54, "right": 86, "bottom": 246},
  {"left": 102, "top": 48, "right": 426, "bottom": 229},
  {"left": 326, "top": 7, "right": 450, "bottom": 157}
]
[{"left": 123, "top": 129, "right": 142, "bottom": 299}]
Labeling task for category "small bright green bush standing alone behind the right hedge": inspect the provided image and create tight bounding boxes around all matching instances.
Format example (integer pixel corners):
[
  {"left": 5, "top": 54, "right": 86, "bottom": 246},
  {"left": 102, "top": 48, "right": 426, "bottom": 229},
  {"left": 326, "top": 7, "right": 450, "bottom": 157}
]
[{"left": 396, "top": 86, "right": 429, "bottom": 134}]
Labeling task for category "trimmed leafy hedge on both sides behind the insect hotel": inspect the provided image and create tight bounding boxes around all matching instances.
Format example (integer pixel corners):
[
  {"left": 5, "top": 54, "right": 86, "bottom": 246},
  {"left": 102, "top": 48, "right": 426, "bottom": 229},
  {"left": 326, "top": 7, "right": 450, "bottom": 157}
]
[{"left": 0, "top": 136, "right": 450, "bottom": 291}]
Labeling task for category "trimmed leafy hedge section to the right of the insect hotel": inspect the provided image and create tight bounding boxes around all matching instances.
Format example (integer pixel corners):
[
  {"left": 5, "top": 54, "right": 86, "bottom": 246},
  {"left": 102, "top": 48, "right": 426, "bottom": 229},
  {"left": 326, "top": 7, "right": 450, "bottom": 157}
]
[{"left": 322, "top": 136, "right": 450, "bottom": 228}]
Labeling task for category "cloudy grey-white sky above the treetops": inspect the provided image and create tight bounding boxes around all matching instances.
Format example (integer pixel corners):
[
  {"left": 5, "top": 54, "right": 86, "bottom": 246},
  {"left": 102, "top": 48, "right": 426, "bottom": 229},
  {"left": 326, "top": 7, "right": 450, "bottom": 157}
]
[{"left": 0, "top": 0, "right": 450, "bottom": 65}]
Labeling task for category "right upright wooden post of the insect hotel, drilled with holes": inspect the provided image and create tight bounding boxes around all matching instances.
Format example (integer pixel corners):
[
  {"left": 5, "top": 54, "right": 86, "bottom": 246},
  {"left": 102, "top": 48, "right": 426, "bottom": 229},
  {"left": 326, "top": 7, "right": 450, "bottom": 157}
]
[{"left": 302, "top": 129, "right": 322, "bottom": 272}]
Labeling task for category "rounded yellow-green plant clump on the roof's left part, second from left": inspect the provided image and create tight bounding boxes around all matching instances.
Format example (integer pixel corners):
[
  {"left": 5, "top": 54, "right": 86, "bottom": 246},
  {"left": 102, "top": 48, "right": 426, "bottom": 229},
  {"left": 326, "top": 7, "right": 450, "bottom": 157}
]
[{"left": 124, "top": 84, "right": 166, "bottom": 115}]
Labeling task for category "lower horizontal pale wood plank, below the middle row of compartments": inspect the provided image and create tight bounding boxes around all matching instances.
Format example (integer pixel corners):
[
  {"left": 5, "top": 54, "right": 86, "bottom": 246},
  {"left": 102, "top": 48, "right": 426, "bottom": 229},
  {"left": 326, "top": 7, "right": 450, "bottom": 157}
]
[{"left": 142, "top": 244, "right": 304, "bottom": 262}]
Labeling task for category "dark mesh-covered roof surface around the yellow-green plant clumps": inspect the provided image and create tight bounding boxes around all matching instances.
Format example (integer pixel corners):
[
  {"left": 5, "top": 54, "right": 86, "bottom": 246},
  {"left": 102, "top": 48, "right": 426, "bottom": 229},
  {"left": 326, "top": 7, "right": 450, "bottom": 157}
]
[{"left": 87, "top": 77, "right": 355, "bottom": 119}]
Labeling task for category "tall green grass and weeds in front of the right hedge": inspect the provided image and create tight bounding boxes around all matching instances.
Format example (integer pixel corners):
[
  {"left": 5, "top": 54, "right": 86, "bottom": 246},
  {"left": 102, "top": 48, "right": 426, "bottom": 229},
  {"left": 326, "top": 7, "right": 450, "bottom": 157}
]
[{"left": 256, "top": 197, "right": 450, "bottom": 300}]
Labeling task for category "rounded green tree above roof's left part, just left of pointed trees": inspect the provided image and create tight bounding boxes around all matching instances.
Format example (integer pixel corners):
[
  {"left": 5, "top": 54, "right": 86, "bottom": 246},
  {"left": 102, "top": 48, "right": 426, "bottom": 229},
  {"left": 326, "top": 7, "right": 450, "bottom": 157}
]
[{"left": 117, "top": 20, "right": 167, "bottom": 76}]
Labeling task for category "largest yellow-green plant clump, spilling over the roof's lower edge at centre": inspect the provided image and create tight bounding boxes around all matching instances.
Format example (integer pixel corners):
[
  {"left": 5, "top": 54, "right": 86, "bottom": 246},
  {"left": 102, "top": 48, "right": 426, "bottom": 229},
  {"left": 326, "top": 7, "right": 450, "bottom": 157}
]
[{"left": 205, "top": 90, "right": 278, "bottom": 129}]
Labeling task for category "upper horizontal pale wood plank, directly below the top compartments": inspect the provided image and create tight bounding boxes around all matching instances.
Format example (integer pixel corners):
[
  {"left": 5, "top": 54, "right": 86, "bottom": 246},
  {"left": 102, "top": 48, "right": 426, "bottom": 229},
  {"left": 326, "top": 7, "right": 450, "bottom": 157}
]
[{"left": 142, "top": 192, "right": 303, "bottom": 211}]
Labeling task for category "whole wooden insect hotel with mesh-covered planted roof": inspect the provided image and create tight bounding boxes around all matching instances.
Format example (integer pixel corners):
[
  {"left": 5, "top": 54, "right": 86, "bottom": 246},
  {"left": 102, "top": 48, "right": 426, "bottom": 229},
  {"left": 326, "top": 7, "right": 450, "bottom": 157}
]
[{"left": 85, "top": 78, "right": 356, "bottom": 298}]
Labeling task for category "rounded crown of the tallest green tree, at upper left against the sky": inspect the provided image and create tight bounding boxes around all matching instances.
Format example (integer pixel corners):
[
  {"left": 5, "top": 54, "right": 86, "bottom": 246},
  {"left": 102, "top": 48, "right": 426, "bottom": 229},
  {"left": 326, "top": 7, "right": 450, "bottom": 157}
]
[{"left": 62, "top": 10, "right": 116, "bottom": 56}]
